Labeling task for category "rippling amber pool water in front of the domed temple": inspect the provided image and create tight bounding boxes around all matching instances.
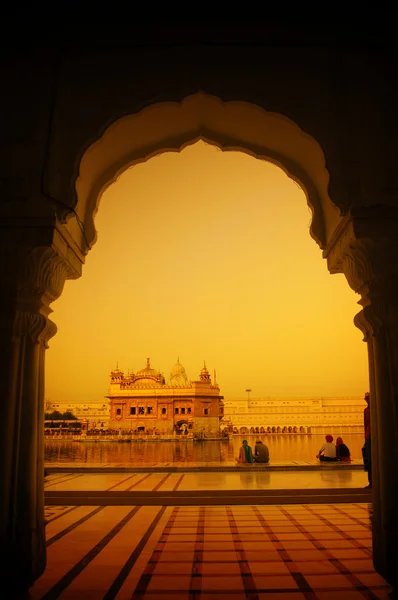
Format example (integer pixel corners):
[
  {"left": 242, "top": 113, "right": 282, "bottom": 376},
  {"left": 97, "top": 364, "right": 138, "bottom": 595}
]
[{"left": 45, "top": 433, "right": 363, "bottom": 466}]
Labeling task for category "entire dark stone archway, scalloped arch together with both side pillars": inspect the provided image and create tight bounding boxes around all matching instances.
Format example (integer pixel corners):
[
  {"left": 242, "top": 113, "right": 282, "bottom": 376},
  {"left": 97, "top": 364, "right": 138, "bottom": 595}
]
[{"left": 0, "top": 92, "right": 398, "bottom": 585}]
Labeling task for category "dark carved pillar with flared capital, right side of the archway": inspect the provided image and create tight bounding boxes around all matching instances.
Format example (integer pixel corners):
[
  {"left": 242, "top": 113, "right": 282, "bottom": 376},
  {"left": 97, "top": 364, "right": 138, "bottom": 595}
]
[{"left": 325, "top": 207, "right": 398, "bottom": 589}]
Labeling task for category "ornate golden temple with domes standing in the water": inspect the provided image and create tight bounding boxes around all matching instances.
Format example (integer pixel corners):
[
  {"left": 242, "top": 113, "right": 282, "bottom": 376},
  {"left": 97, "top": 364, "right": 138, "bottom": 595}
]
[{"left": 106, "top": 358, "right": 224, "bottom": 437}]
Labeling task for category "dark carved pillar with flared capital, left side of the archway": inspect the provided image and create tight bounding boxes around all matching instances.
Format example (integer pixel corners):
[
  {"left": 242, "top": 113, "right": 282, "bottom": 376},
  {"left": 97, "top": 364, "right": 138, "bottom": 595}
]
[{"left": 0, "top": 218, "right": 81, "bottom": 597}]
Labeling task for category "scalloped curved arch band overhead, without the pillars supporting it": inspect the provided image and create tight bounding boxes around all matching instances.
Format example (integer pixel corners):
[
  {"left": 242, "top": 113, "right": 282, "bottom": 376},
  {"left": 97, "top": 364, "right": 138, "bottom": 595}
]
[{"left": 71, "top": 92, "right": 341, "bottom": 252}]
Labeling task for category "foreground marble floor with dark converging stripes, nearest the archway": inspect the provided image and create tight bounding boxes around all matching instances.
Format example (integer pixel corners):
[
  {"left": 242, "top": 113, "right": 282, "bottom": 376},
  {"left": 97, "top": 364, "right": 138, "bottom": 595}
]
[{"left": 31, "top": 504, "right": 390, "bottom": 600}]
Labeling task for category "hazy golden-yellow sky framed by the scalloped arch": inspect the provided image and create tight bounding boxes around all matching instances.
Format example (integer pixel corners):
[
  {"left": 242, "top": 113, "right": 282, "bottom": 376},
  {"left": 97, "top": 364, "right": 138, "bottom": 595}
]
[{"left": 46, "top": 142, "right": 369, "bottom": 402}]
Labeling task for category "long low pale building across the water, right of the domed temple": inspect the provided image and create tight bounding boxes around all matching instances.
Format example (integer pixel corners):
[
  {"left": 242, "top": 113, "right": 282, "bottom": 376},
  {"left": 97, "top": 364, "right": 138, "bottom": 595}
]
[{"left": 221, "top": 397, "right": 366, "bottom": 434}]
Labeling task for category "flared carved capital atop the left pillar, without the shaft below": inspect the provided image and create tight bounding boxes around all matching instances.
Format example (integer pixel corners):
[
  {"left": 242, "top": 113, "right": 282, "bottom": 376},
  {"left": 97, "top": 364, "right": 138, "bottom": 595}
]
[{"left": 0, "top": 216, "right": 84, "bottom": 347}]
